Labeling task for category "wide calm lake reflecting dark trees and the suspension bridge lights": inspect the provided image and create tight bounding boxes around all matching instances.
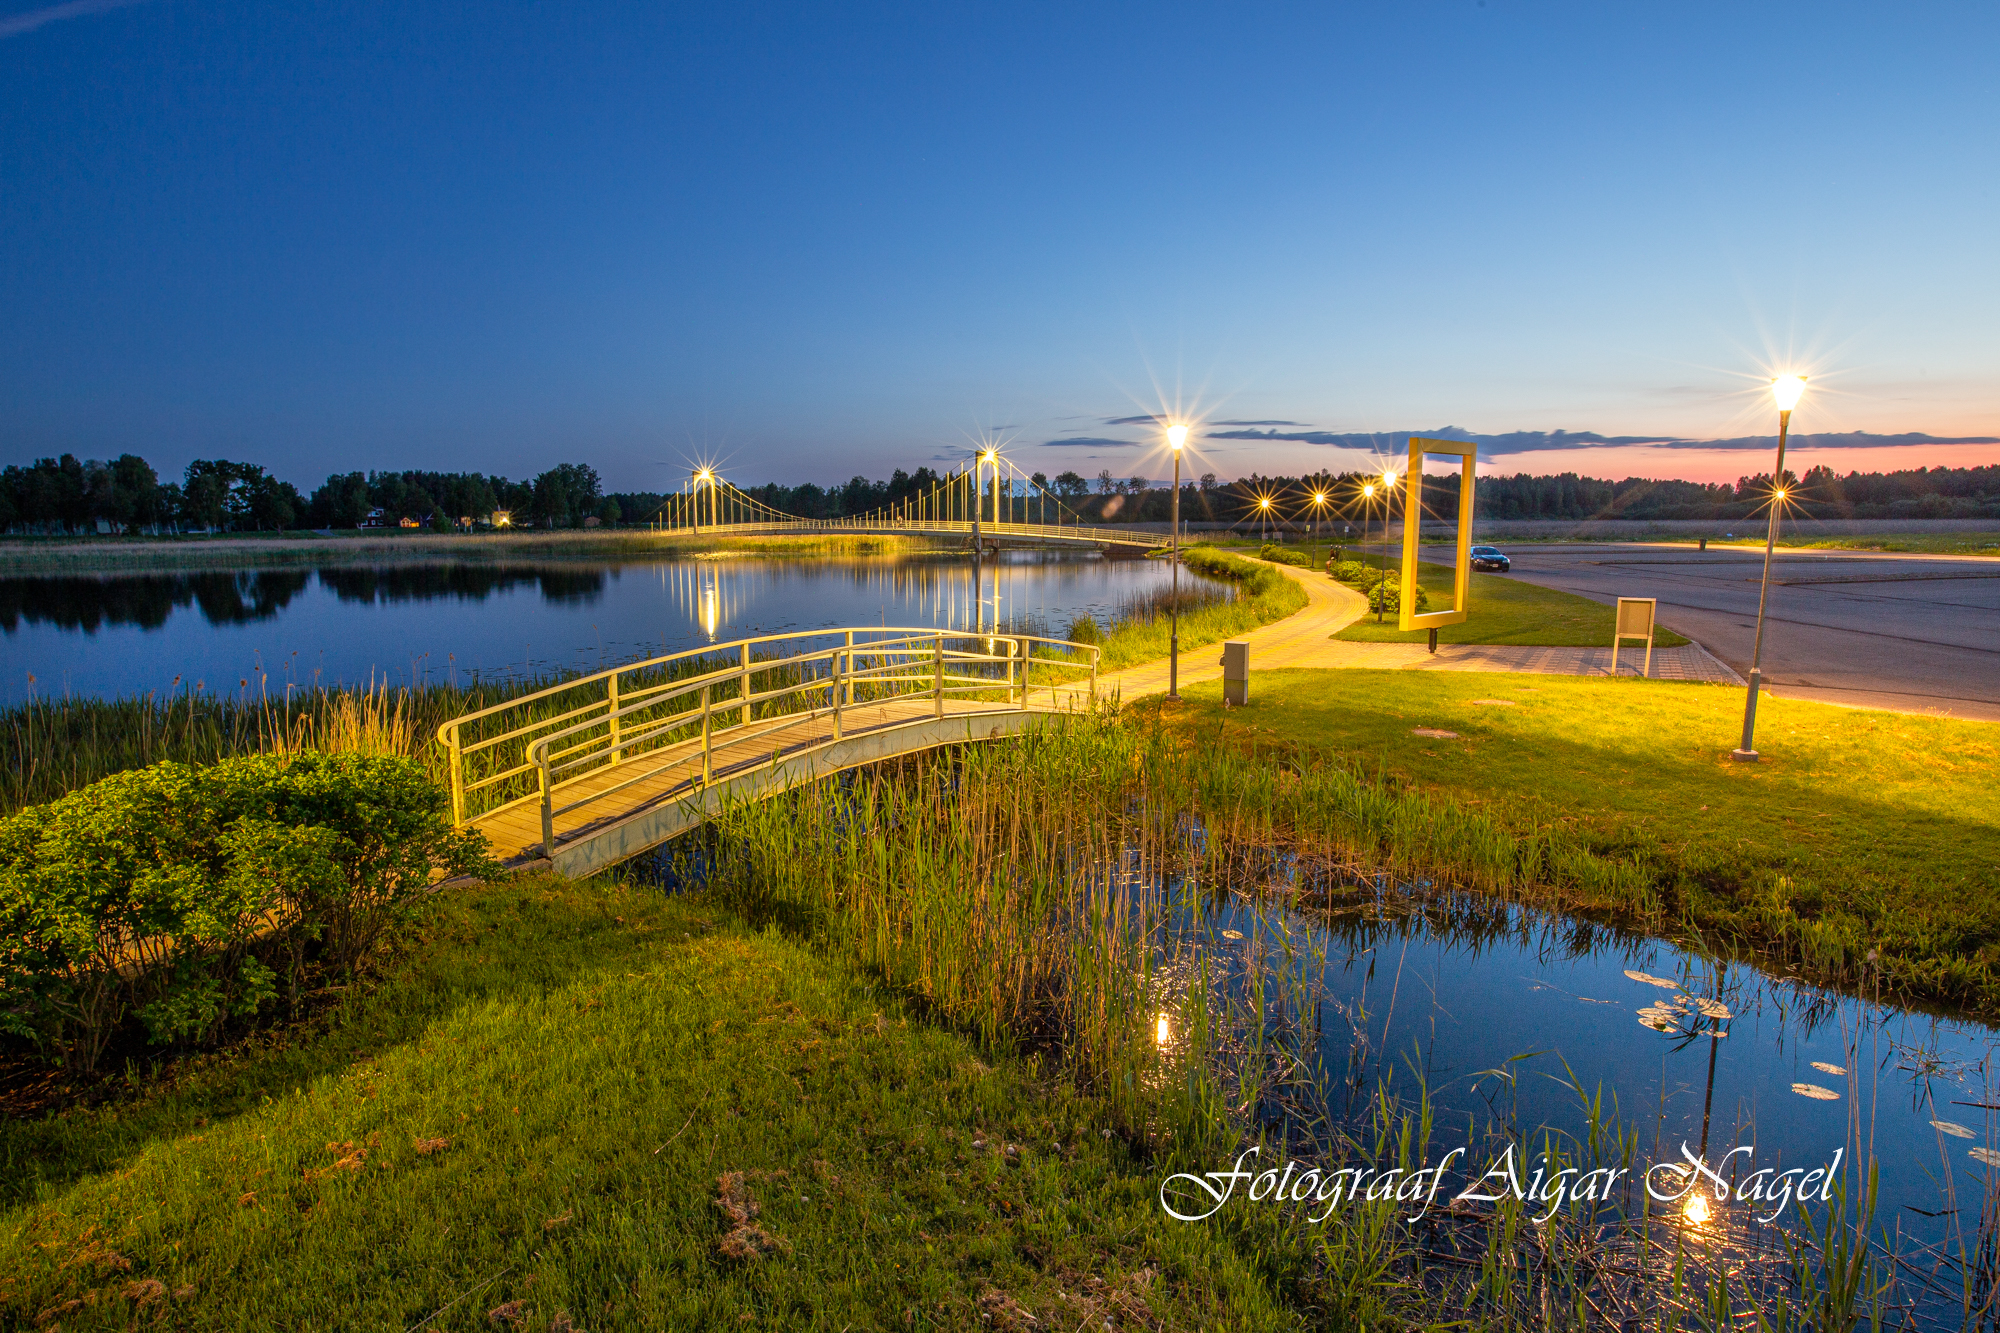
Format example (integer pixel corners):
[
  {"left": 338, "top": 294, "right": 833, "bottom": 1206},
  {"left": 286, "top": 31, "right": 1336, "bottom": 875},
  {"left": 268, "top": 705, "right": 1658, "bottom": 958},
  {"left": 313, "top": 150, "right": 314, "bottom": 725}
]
[{"left": 0, "top": 552, "right": 1192, "bottom": 703}]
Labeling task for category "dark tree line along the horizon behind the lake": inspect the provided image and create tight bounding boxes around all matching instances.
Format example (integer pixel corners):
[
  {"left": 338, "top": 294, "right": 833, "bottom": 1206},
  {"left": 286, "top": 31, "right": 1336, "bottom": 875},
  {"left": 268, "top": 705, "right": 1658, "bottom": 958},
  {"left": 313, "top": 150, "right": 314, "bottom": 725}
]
[{"left": 0, "top": 454, "right": 2000, "bottom": 534}]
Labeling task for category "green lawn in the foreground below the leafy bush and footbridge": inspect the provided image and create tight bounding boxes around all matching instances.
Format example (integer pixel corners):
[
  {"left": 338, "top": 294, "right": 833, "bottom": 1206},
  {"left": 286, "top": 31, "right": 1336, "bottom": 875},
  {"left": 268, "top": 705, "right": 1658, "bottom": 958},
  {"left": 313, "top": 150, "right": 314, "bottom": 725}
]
[{"left": 0, "top": 879, "right": 1294, "bottom": 1333}]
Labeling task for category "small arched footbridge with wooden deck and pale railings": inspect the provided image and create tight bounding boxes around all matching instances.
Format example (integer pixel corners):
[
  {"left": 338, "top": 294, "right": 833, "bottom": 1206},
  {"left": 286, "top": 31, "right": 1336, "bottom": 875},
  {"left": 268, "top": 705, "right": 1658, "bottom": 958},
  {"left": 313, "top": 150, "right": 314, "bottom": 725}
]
[{"left": 438, "top": 626, "right": 1098, "bottom": 877}]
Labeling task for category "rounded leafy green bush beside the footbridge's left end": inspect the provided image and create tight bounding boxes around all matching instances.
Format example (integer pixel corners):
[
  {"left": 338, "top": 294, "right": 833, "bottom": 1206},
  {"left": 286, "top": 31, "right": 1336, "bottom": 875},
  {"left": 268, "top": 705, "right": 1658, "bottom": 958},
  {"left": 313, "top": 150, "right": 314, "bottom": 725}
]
[{"left": 0, "top": 753, "right": 492, "bottom": 1069}]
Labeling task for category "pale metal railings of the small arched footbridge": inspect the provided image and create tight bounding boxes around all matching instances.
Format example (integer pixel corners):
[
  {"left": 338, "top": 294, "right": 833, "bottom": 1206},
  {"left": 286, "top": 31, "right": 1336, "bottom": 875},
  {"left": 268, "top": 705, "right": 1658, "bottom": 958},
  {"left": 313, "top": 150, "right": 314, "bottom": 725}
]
[{"left": 438, "top": 626, "right": 1100, "bottom": 849}]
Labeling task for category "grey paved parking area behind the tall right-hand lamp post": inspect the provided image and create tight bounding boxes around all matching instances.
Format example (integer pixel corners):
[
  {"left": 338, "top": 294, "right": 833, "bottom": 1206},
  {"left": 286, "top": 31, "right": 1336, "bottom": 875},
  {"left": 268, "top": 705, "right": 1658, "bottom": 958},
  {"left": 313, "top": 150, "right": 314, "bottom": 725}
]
[{"left": 1456, "top": 544, "right": 2000, "bottom": 721}]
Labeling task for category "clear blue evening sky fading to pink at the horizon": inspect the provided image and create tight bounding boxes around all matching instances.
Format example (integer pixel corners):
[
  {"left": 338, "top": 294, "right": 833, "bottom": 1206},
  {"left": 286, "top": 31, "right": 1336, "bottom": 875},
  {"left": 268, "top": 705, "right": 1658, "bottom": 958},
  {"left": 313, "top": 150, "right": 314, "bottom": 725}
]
[{"left": 0, "top": 0, "right": 2000, "bottom": 488}]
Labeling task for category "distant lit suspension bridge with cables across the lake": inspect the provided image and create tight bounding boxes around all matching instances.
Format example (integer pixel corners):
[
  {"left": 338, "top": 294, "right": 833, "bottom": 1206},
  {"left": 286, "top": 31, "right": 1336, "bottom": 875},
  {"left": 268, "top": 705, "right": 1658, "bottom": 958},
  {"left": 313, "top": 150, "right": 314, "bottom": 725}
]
[{"left": 652, "top": 450, "right": 1172, "bottom": 550}]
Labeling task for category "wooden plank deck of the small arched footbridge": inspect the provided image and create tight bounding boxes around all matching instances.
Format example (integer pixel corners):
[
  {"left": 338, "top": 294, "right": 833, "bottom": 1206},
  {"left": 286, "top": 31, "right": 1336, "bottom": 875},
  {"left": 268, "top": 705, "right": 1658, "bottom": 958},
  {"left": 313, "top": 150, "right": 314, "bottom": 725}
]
[{"left": 470, "top": 693, "right": 1060, "bottom": 877}]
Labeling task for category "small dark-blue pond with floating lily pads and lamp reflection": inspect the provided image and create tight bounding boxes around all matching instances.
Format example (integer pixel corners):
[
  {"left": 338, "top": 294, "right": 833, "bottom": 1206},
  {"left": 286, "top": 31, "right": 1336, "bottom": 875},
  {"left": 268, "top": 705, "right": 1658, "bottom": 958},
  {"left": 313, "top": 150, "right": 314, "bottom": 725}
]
[{"left": 1162, "top": 873, "right": 2000, "bottom": 1329}]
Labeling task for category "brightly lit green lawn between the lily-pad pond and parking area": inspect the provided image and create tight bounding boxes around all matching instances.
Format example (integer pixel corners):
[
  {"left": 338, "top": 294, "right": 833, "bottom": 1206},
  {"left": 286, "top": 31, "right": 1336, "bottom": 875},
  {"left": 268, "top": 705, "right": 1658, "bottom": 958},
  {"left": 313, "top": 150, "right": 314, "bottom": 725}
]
[{"left": 1144, "top": 671, "right": 2000, "bottom": 1015}]
